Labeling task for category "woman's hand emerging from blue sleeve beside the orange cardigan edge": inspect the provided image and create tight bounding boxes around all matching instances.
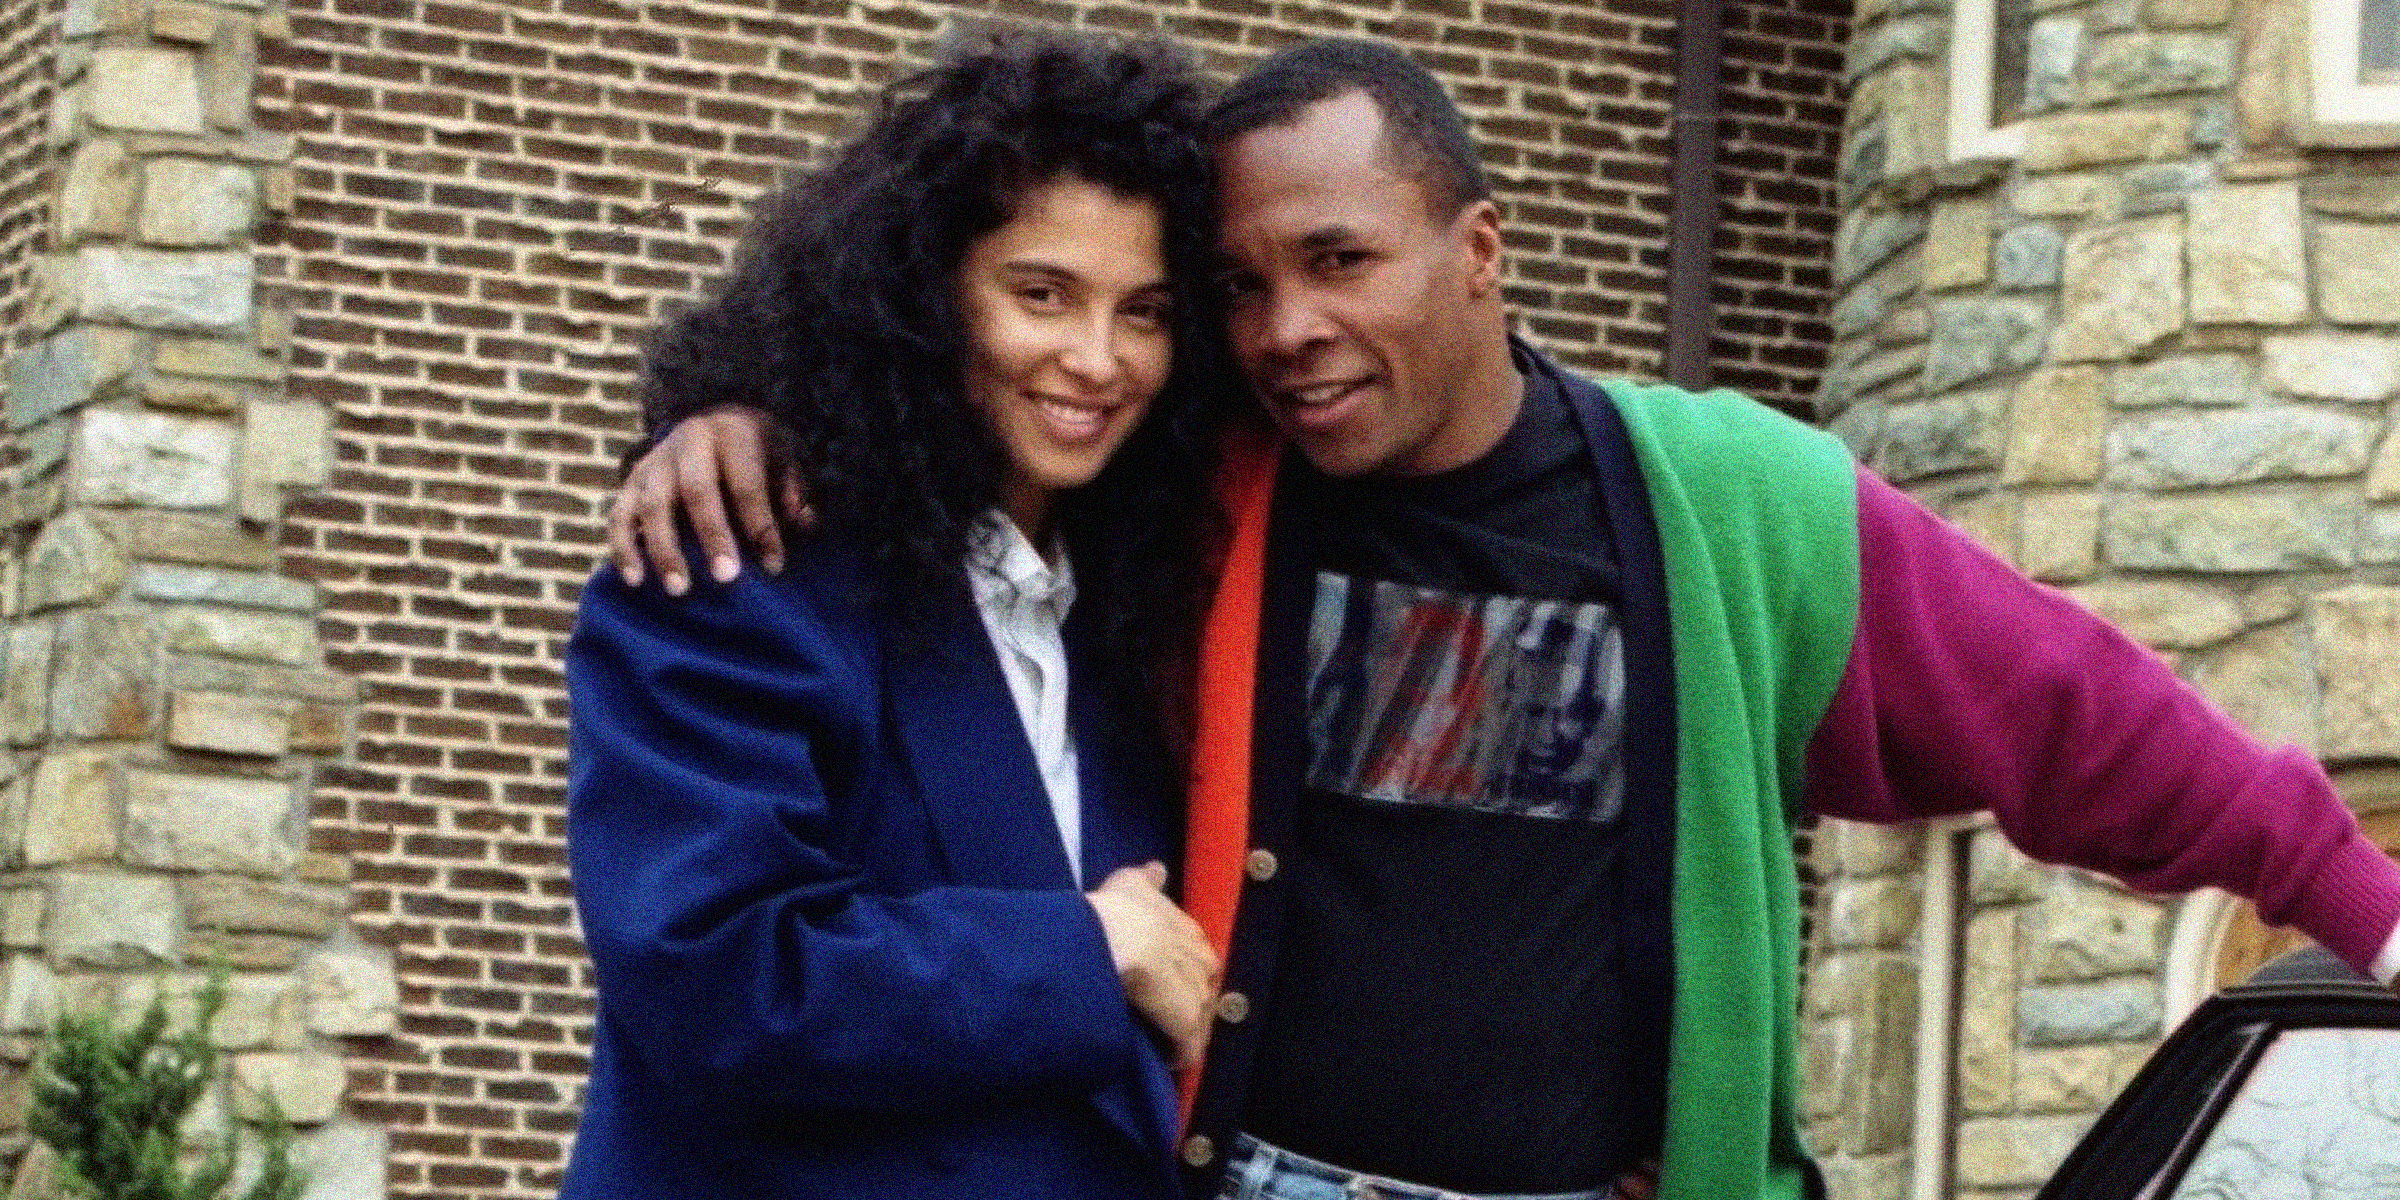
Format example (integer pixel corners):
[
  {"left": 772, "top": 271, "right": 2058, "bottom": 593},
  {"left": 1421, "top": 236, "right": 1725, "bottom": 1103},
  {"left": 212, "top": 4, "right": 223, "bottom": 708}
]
[{"left": 1087, "top": 862, "right": 1219, "bottom": 1070}]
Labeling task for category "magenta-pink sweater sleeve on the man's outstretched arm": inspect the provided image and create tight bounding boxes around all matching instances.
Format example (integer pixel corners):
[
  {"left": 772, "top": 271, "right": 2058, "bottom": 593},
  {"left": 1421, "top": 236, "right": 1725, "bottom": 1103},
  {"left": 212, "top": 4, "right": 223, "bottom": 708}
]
[{"left": 1807, "top": 463, "right": 2400, "bottom": 974}]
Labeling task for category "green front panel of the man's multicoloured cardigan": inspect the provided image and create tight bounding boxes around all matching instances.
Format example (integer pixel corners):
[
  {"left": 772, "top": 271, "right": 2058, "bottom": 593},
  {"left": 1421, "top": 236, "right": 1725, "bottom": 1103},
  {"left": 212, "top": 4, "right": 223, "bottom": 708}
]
[{"left": 1606, "top": 382, "right": 1858, "bottom": 1200}]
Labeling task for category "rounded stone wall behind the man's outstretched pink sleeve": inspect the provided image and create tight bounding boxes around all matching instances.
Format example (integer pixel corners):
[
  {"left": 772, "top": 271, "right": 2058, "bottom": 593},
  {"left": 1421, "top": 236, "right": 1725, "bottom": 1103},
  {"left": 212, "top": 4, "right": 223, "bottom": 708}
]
[{"left": 1812, "top": 0, "right": 2400, "bottom": 1200}]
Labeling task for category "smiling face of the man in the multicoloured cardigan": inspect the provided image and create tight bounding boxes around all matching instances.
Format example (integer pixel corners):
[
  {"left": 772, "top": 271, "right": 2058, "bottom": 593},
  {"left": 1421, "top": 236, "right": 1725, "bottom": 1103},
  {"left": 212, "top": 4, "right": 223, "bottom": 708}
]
[{"left": 1219, "top": 91, "right": 1498, "bottom": 475}]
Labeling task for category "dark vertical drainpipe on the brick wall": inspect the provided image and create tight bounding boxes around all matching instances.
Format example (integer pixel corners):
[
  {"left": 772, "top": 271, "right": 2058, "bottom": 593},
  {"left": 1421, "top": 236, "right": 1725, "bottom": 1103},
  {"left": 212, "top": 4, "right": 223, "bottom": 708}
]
[{"left": 1666, "top": 0, "right": 1726, "bottom": 389}]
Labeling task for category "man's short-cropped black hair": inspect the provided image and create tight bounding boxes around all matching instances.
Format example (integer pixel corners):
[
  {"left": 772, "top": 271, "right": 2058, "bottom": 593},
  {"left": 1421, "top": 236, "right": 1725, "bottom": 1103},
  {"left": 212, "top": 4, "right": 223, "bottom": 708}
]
[{"left": 1207, "top": 38, "right": 1493, "bottom": 216}]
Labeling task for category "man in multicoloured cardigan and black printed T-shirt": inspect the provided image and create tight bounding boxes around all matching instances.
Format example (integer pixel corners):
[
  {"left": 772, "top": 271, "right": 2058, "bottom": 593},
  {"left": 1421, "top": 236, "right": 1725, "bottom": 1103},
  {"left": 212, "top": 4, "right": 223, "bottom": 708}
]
[{"left": 612, "top": 41, "right": 2400, "bottom": 1200}]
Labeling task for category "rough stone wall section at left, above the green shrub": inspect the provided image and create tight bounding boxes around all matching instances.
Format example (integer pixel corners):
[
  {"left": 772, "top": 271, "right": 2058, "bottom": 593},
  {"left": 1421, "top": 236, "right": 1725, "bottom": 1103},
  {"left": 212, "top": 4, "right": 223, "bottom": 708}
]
[{"left": 0, "top": 0, "right": 396, "bottom": 1198}]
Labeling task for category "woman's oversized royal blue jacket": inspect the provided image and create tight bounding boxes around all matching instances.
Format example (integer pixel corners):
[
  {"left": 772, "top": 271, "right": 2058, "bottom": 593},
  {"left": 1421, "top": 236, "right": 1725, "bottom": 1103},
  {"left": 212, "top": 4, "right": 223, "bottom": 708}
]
[{"left": 562, "top": 538, "right": 1176, "bottom": 1200}]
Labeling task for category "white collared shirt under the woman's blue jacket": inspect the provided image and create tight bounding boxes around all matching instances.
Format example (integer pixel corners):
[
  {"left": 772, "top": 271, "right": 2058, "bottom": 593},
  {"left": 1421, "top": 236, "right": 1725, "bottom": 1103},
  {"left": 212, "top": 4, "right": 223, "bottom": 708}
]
[{"left": 967, "top": 511, "right": 1082, "bottom": 886}]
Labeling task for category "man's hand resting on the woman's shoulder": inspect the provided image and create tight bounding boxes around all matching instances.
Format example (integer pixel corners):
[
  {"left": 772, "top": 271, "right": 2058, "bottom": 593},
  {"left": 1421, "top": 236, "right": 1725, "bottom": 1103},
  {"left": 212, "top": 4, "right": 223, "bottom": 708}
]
[{"left": 607, "top": 403, "right": 816, "bottom": 595}]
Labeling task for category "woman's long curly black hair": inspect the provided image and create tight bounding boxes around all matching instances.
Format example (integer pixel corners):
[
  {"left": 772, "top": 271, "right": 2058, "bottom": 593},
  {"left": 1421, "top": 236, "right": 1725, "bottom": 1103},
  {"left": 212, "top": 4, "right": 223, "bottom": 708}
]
[{"left": 643, "top": 29, "right": 1234, "bottom": 739}]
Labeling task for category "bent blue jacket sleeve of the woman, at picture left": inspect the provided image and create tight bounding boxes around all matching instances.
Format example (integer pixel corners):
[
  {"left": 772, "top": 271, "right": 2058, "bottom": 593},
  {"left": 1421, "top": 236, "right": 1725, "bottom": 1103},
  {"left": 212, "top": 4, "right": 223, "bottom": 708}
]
[{"left": 566, "top": 569, "right": 1142, "bottom": 1111}]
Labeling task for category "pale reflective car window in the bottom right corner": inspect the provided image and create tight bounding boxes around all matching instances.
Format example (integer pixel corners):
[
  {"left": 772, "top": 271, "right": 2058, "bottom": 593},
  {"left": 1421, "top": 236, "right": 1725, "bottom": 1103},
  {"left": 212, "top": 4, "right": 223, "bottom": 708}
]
[{"left": 2172, "top": 1030, "right": 2400, "bottom": 1200}]
